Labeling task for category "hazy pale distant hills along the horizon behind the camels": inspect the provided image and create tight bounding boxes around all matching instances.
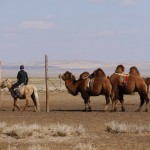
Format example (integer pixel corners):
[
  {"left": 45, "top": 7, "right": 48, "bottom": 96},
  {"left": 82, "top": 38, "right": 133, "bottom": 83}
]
[{"left": 2, "top": 60, "right": 150, "bottom": 77}]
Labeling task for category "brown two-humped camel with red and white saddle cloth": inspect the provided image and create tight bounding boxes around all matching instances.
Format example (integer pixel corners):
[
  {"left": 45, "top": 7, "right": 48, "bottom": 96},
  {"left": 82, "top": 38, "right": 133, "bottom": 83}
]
[{"left": 110, "top": 65, "right": 149, "bottom": 111}]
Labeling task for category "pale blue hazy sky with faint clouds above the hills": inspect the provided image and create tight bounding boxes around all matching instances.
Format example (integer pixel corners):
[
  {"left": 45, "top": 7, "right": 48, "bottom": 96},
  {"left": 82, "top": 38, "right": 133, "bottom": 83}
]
[{"left": 0, "top": 0, "right": 150, "bottom": 63}]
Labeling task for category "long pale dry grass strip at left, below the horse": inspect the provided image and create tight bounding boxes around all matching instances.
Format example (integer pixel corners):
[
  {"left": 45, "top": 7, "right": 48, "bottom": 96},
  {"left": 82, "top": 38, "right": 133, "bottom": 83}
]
[{"left": 0, "top": 122, "right": 85, "bottom": 139}]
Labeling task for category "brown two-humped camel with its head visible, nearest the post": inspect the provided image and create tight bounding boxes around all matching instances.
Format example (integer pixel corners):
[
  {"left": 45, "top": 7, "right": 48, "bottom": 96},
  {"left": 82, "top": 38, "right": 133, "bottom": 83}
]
[{"left": 60, "top": 68, "right": 111, "bottom": 111}]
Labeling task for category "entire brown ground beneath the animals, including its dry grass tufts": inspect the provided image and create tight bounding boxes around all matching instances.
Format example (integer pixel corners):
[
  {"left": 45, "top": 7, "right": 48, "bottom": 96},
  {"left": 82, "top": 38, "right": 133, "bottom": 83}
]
[{"left": 0, "top": 90, "right": 150, "bottom": 150}]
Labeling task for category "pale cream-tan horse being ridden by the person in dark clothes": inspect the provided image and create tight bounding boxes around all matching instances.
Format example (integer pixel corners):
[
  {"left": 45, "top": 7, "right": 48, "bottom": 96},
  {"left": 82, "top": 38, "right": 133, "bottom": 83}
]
[{"left": 0, "top": 79, "right": 40, "bottom": 111}]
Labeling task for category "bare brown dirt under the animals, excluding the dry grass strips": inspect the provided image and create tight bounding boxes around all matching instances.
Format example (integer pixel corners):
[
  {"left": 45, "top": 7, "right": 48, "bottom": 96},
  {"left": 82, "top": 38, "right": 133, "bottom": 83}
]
[{"left": 0, "top": 91, "right": 150, "bottom": 150}]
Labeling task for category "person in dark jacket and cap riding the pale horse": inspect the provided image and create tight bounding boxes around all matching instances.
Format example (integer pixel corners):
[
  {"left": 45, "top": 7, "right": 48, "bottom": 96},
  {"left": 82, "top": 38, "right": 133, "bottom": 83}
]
[{"left": 12, "top": 65, "right": 29, "bottom": 97}]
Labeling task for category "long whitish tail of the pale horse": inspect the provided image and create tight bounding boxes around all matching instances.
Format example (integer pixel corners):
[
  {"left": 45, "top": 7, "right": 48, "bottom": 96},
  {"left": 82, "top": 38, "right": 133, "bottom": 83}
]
[{"left": 32, "top": 87, "right": 40, "bottom": 111}]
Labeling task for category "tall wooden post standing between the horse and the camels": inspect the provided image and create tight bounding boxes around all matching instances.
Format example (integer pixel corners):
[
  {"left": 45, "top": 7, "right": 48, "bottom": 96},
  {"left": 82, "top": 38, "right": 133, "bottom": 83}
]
[{"left": 45, "top": 55, "right": 49, "bottom": 112}]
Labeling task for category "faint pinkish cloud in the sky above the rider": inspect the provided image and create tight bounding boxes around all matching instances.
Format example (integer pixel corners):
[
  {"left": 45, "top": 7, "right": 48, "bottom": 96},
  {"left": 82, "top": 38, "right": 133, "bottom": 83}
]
[{"left": 19, "top": 20, "right": 55, "bottom": 30}]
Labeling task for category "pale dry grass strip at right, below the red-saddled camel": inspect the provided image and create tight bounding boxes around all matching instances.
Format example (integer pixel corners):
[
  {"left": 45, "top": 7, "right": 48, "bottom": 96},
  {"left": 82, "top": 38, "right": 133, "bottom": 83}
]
[{"left": 106, "top": 121, "right": 150, "bottom": 134}]
